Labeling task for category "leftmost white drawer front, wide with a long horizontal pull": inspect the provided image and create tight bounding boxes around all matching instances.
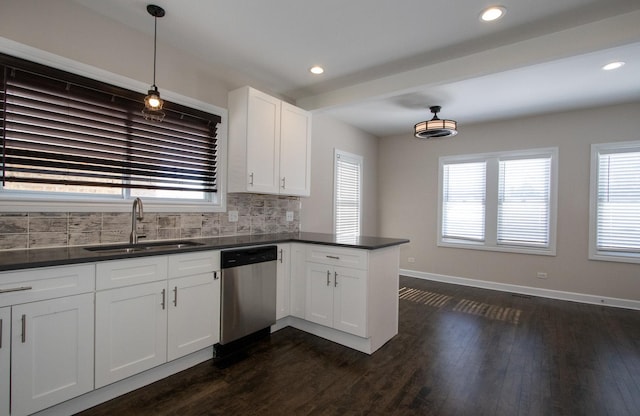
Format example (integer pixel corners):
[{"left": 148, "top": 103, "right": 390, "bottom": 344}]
[{"left": 0, "top": 263, "right": 95, "bottom": 307}]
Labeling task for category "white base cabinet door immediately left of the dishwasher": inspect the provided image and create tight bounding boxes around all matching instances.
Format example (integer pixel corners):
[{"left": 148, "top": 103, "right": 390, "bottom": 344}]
[{"left": 167, "top": 272, "right": 220, "bottom": 361}]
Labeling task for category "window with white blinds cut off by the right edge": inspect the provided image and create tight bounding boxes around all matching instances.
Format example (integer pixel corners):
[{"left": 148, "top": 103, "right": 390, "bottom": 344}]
[{"left": 589, "top": 142, "right": 640, "bottom": 263}]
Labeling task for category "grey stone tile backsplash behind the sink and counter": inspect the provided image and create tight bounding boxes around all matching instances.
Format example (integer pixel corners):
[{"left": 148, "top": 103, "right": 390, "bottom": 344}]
[{"left": 0, "top": 194, "right": 301, "bottom": 250}]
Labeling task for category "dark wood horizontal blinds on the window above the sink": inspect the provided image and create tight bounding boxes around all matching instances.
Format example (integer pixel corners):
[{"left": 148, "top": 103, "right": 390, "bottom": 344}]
[{"left": 0, "top": 54, "right": 221, "bottom": 192}]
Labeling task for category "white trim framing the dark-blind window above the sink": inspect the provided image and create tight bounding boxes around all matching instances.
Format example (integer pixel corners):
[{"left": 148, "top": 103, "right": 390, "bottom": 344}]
[{"left": 0, "top": 37, "right": 228, "bottom": 212}]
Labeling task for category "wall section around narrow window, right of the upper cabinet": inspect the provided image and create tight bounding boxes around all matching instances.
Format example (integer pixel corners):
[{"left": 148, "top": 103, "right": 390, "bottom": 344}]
[{"left": 300, "top": 113, "right": 380, "bottom": 237}]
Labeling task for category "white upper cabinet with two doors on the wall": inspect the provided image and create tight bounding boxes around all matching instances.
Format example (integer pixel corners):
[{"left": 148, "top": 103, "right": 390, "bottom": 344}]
[{"left": 228, "top": 87, "right": 311, "bottom": 196}]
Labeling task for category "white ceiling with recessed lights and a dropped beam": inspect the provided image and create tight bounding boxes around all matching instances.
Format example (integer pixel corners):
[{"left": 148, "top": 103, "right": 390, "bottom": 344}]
[{"left": 75, "top": 0, "right": 640, "bottom": 137}]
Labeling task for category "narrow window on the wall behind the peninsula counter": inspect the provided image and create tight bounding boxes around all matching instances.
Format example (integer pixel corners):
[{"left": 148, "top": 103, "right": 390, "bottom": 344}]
[{"left": 334, "top": 149, "right": 362, "bottom": 239}]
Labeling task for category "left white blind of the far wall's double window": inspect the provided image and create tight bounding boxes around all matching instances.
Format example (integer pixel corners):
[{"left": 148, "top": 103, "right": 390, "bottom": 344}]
[{"left": 442, "top": 162, "right": 487, "bottom": 241}]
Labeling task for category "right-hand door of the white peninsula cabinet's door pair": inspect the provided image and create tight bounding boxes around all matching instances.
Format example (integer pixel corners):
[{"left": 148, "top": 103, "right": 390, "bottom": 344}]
[{"left": 332, "top": 267, "right": 368, "bottom": 337}]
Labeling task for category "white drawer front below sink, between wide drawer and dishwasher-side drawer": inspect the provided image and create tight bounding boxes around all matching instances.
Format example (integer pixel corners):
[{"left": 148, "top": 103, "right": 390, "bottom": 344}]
[{"left": 96, "top": 256, "right": 167, "bottom": 290}]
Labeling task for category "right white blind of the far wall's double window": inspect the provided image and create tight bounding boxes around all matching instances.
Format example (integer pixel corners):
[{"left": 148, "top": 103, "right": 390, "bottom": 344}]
[{"left": 497, "top": 157, "right": 551, "bottom": 247}]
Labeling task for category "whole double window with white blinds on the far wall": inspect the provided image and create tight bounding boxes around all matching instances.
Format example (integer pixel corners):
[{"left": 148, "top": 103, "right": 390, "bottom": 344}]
[{"left": 438, "top": 148, "right": 557, "bottom": 255}]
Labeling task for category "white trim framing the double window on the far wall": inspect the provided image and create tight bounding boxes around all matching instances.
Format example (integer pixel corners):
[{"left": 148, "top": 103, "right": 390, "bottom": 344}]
[{"left": 436, "top": 147, "right": 558, "bottom": 256}]
